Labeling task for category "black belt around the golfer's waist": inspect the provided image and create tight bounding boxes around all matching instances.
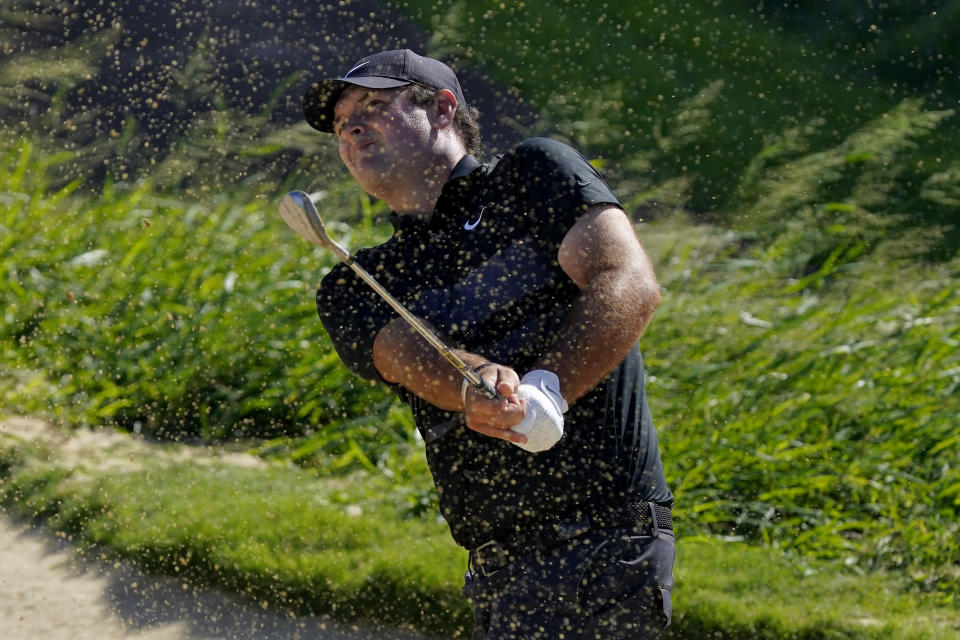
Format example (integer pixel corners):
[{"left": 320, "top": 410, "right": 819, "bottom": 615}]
[{"left": 469, "top": 502, "right": 673, "bottom": 576}]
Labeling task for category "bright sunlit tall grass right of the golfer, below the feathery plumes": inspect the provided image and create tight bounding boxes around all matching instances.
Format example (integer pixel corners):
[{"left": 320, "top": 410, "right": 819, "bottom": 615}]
[{"left": 643, "top": 214, "right": 960, "bottom": 592}]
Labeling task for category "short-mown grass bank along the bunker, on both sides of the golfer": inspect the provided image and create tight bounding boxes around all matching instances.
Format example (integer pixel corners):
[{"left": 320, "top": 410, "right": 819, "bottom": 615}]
[{"left": 0, "top": 419, "right": 960, "bottom": 640}]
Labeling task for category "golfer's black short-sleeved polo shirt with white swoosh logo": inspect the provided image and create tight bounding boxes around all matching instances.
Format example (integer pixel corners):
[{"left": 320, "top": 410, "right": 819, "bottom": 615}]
[{"left": 317, "top": 138, "right": 673, "bottom": 548}]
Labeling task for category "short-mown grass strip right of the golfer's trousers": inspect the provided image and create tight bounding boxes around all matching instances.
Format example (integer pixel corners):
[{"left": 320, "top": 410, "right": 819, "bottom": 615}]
[{"left": 673, "top": 538, "right": 960, "bottom": 640}]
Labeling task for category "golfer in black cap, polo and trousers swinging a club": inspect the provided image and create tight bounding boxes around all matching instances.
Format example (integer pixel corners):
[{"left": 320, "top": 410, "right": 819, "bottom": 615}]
[{"left": 303, "top": 50, "right": 674, "bottom": 640}]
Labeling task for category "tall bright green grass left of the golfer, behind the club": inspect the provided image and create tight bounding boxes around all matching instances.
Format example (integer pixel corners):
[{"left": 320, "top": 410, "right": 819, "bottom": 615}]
[{"left": 0, "top": 138, "right": 406, "bottom": 439}]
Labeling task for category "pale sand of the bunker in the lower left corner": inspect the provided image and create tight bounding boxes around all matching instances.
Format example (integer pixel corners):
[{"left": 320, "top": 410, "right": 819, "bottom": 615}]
[{"left": 0, "top": 514, "right": 442, "bottom": 640}]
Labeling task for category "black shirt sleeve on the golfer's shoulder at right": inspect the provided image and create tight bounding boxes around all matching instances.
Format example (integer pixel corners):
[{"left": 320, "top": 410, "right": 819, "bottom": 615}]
[{"left": 512, "top": 138, "right": 620, "bottom": 246}]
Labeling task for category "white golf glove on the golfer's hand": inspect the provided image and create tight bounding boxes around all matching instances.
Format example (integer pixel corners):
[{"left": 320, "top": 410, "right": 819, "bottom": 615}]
[{"left": 511, "top": 369, "right": 569, "bottom": 452}]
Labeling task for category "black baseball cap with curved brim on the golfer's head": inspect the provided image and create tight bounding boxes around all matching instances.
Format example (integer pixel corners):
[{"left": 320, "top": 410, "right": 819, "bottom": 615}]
[{"left": 303, "top": 49, "right": 465, "bottom": 133}]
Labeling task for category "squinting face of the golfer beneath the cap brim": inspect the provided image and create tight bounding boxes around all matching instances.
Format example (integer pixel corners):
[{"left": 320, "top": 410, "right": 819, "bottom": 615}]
[{"left": 333, "top": 86, "right": 436, "bottom": 199}]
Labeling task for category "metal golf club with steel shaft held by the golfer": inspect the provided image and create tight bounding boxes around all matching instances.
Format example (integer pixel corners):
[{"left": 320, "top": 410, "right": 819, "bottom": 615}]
[{"left": 280, "top": 191, "right": 500, "bottom": 399}]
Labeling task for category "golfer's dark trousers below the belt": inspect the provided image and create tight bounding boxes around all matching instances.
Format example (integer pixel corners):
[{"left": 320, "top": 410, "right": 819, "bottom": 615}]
[{"left": 463, "top": 529, "right": 675, "bottom": 640}]
